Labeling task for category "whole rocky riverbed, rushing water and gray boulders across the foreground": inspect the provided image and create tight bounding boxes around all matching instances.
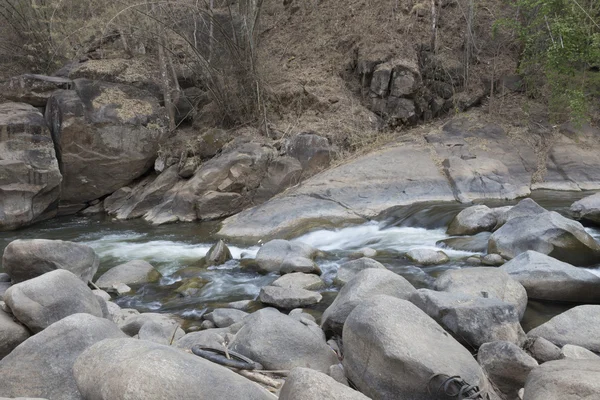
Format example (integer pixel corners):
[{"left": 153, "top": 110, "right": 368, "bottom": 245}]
[{"left": 0, "top": 196, "right": 600, "bottom": 400}]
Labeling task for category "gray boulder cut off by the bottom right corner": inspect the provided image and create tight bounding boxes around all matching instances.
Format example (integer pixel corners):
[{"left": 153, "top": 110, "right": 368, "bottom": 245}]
[{"left": 523, "top": 360, "right": 600, "bottom": 400}]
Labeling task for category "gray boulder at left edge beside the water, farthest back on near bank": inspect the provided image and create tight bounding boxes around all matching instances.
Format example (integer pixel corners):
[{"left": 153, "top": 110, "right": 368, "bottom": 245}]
[{"left": 2, "top": 239, "right": 100, "bottom": 283}]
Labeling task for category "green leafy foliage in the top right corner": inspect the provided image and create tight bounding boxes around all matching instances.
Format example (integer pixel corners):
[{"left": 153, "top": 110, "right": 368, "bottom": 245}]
[{"left": 501, "top": 0, "right": 600, "bottom": 122}]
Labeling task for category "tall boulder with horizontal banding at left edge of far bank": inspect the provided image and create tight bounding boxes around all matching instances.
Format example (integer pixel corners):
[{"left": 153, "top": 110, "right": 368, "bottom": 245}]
[{"left": 0, "top": 103, "right": 62, "bottom": 231}]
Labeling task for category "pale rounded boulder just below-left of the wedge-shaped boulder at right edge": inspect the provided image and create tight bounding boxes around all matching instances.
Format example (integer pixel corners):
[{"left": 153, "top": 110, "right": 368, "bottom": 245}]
[{"left": 434, "top": 267, "right": 527, "bottom": 318}]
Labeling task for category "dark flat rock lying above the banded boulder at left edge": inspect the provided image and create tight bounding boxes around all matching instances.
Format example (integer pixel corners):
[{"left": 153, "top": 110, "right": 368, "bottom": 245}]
[{"left": 0, "top": 74, "right": 73, "bottom": 107}]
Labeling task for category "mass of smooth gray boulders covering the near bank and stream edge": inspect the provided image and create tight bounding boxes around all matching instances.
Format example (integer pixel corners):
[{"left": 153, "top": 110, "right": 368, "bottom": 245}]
[{"left": 0, "top": 195, "right": 600, "bottom": 400}]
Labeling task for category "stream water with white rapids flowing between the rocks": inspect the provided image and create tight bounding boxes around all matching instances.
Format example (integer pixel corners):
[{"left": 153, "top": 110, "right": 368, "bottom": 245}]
[{"left": 0, "top": 192, "right": 600, "bottom": 330}]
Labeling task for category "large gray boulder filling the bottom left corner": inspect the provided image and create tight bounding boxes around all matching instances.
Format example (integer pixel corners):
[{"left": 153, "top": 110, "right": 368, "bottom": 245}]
[{"left": 0, "top": 314, "right": 125, "bottom": 400}]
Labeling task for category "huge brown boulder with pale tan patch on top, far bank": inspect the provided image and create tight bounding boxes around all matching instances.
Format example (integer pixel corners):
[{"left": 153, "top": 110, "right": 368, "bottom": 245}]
[{"left": 46, "top": 79, "right": 167, "bottom": 208}]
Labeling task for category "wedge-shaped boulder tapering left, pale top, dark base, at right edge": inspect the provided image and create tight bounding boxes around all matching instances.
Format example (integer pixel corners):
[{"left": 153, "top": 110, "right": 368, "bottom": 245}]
[{"left": 500, "top": 250, "right": 600, "bottom": 303}]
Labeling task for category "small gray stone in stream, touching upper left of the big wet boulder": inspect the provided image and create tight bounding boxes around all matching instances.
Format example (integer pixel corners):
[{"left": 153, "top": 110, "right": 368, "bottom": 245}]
[{"left": 446, "top": 205, "right": 511, "bottom": 236}]
